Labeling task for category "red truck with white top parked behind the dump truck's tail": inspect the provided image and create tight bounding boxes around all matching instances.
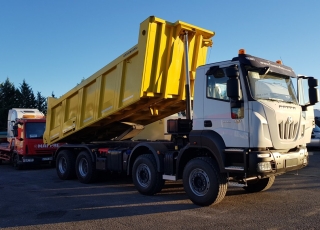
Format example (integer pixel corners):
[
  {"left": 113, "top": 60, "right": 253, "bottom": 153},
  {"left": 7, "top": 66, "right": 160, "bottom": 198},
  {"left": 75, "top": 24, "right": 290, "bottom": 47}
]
[{"left": 0, "top": 108, "right": 59, "bottom": 169}]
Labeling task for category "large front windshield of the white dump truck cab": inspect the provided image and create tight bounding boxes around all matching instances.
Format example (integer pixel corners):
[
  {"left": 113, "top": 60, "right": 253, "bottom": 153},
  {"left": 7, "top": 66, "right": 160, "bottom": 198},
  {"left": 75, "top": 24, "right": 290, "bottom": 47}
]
[{"left": 248, "top": 69, "right": 298, "bottom": 104}]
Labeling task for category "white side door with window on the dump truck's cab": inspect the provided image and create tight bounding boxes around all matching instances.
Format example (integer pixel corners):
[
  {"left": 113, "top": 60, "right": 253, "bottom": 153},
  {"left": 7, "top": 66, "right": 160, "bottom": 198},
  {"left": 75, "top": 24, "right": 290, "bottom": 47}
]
[{"left": 203, "top": 64, "right": 249, "bottom": 147}]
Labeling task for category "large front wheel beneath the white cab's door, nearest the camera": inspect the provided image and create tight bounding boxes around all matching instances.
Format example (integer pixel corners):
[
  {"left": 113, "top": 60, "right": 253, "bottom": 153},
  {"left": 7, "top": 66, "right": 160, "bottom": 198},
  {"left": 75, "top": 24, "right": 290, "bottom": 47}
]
[{"left": 183, "top": 157, "right": 228, "bottom": 206}]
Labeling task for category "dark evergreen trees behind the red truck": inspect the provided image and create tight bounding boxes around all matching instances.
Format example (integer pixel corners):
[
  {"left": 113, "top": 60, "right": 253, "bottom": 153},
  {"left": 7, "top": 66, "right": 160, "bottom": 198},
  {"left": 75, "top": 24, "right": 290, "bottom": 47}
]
[{"left": 0, "top": 78, "right": 54, "bottom": 131}]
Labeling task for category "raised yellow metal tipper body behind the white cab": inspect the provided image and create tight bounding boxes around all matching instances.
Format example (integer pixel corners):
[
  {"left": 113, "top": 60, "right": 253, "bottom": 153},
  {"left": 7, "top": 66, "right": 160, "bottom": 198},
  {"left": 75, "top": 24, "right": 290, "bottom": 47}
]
[{"left": 44, "top": 16, "right": 214, "bottom": 144}]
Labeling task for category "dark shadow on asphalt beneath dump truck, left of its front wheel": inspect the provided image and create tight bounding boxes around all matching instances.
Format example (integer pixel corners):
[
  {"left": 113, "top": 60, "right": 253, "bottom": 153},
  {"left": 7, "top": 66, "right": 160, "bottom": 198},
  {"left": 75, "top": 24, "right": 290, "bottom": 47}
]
[{"left": 0, "top": 172, "right": 199, "bottom": 228}]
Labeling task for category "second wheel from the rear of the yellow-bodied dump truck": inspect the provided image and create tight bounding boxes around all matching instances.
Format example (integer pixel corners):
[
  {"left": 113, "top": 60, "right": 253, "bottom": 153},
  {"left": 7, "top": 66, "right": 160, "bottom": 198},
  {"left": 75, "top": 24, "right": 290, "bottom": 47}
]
[{"left": 76, "top": 151, "right": 97, "bottom": 184}]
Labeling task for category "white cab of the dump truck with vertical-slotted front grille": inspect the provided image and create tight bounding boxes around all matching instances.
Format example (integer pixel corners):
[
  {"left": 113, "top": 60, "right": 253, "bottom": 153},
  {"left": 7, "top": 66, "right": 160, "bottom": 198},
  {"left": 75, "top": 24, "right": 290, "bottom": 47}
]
[{"left": 191, "top": 50, "right": 318, "bottom": 177}]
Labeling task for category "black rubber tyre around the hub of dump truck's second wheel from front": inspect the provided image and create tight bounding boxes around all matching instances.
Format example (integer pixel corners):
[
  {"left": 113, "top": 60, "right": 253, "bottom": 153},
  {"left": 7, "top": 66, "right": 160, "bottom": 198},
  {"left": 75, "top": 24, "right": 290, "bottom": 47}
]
[{"left": 132, "top": 154, "right": 165, "bottom": 196}]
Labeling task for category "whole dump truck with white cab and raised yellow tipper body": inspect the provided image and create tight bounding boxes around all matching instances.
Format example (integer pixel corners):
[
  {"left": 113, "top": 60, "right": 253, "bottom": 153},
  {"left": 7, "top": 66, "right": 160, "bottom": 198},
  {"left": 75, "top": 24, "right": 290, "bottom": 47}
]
[{"left": 44, "top": 16, "right": 318, "bottom": 205}]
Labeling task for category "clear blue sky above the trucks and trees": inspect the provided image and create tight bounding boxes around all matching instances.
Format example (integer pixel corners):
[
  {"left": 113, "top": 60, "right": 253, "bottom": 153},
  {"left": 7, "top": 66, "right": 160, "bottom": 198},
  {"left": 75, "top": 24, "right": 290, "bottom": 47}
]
[{"left": 0, "top": 0, "right": 320, "bottom": 108}]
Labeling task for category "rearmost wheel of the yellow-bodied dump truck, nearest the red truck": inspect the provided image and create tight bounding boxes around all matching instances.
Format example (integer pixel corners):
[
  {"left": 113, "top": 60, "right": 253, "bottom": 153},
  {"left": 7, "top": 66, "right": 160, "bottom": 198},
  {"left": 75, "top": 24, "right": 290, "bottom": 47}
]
[{"left": 56, "top": 150, "right": 76, "bottom": 180}]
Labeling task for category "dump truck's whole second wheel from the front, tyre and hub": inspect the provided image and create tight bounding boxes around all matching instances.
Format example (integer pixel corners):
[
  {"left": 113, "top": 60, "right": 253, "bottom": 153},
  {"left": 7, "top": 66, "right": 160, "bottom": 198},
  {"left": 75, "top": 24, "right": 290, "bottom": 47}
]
[{"left": 132, "top": 154, "right": 164, "bottom": 195}]
